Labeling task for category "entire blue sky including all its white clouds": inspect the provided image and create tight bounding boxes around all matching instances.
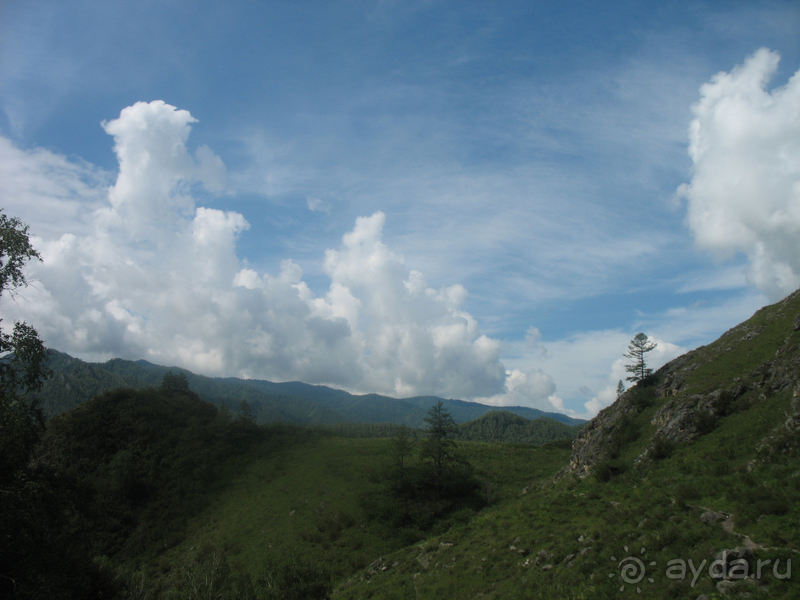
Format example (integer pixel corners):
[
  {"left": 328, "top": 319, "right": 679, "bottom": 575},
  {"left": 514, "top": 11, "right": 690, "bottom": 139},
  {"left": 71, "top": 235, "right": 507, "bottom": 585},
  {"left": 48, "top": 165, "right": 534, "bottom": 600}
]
[{"left": 0, "top": 0, "right": 800, "bottom": 415}]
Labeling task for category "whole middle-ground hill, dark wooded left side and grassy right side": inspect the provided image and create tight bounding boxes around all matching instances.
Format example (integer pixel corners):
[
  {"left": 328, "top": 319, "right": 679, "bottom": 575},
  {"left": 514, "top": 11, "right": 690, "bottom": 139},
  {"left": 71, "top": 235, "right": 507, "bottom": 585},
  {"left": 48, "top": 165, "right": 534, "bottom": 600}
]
[{"left": 0, "top": 372, "right": 567, "bottom": 599}]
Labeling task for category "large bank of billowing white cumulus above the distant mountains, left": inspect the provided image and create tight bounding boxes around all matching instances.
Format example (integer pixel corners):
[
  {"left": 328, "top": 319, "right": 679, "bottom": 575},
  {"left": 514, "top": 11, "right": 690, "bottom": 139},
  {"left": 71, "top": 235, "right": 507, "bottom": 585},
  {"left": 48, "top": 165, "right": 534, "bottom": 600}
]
[{"left": 0, "top": 101, "right": 506, "bottom": 399}]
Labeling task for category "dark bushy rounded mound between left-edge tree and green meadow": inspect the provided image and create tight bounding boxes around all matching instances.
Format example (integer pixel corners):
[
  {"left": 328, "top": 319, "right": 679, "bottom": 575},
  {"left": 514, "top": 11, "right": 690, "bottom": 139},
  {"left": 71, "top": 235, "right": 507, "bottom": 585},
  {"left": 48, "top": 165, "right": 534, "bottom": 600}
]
[{"left": 42, "top": 388, "right": 264, "bottom": 557}]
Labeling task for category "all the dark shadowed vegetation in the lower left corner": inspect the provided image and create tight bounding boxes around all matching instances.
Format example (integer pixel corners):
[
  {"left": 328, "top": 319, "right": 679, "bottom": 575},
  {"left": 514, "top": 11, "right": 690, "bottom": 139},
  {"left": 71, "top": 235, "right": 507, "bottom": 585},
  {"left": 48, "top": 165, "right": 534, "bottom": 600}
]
[{"left": 0, "top": 374, "right": 320, "bottom": 599}]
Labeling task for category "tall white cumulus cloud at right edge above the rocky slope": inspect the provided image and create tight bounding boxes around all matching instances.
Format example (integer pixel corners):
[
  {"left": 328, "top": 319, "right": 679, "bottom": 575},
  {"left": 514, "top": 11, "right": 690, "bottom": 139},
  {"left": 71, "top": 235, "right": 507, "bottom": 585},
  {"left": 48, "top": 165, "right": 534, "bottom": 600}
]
[{"left": 679, "top": 48, "right": 800, "bottom": 300}]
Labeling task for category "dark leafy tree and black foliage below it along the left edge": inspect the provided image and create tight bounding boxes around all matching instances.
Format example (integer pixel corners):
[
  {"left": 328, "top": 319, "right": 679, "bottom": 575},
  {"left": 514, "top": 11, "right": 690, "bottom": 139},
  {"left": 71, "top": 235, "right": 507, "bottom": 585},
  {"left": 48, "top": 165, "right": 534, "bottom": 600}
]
[{"left": 0, "top": 211, "right": 114, "bottom": 600}]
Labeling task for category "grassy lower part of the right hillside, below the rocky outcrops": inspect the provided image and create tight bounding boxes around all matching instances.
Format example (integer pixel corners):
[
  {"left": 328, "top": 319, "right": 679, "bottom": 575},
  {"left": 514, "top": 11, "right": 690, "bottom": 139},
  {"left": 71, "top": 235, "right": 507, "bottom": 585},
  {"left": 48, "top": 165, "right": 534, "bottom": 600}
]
[{"left": 334, "top": 391, "right": 800, "bottom": 600}]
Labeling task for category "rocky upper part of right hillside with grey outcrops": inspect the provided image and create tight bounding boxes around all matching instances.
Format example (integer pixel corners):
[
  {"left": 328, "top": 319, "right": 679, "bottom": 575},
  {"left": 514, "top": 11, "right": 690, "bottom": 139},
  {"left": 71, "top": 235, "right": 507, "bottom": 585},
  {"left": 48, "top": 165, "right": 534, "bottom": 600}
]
[{"left": 558, "top": 290, "right": 800, "bottom": 478}]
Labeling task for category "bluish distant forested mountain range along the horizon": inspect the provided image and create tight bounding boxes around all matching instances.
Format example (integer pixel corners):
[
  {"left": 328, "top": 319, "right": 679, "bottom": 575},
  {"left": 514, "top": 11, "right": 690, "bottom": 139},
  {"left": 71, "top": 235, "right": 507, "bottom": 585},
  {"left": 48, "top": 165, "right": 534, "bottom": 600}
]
[{"left": 34, "top": 350, "right": 586, "bottom": 428}]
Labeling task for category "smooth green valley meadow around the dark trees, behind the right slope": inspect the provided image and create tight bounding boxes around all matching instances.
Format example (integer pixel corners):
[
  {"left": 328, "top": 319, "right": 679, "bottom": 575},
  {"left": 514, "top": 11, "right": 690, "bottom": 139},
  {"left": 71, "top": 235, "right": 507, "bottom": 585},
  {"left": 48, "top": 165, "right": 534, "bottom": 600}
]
[{"left": 117, "top": 431, "right": 569, "bottom": 589}]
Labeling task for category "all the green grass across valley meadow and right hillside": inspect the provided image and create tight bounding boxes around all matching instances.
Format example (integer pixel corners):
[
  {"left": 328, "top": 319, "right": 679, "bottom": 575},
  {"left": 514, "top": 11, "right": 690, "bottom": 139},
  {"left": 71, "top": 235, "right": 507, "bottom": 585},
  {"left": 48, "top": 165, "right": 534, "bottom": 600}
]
[{"left": 111, "top": 290, "right": 800, "bottom": 600}]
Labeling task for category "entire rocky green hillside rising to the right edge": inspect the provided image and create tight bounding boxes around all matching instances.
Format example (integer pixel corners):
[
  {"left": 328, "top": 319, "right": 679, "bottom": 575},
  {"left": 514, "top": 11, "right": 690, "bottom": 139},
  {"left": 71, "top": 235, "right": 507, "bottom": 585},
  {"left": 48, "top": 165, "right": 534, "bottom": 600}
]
[{"left": 334, "top": 294, "right": 800, "bottom": 599}]
